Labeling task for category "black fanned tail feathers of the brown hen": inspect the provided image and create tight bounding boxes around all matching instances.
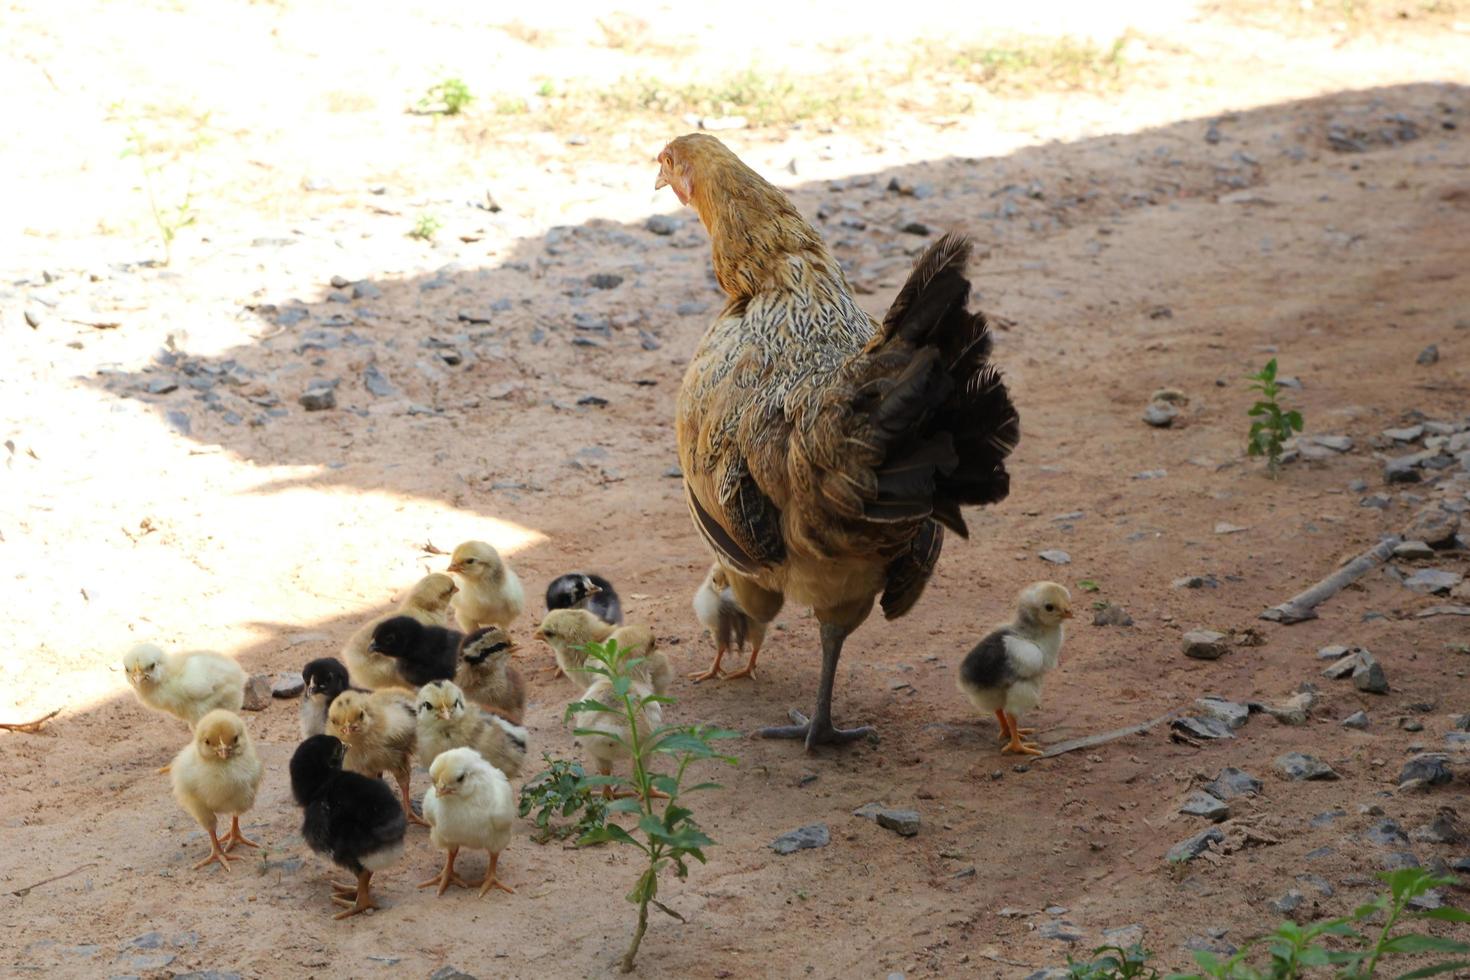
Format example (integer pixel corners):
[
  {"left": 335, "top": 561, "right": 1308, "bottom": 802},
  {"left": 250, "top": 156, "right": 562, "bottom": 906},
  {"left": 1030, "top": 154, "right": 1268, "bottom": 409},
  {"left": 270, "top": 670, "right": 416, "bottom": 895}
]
[{"left": 854, "top": 232, "right": 1020, "bottom": 538}]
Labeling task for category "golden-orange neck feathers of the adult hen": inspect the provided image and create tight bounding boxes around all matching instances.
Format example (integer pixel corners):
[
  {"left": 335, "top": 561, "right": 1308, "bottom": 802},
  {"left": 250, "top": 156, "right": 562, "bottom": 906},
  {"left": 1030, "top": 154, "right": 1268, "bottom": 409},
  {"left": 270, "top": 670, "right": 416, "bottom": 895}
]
[{"left": 689, "top": 151, "right": 847, "bottom": 300}]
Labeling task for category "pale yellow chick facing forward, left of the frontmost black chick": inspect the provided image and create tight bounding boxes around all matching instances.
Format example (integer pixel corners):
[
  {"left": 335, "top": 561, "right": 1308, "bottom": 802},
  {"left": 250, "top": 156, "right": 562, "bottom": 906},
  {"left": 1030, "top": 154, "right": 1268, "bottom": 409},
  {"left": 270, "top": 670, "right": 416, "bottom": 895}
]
[{"left": 171, "top": 708, "right": 263, "bottom": 871}]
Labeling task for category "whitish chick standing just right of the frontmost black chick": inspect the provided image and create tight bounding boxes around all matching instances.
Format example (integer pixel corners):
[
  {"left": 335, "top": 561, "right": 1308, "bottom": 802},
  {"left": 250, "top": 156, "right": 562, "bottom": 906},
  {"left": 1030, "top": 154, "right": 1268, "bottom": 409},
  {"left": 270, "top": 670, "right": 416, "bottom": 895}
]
[{"left": 419, "top": 748, "right": 516, "bottom": 898}]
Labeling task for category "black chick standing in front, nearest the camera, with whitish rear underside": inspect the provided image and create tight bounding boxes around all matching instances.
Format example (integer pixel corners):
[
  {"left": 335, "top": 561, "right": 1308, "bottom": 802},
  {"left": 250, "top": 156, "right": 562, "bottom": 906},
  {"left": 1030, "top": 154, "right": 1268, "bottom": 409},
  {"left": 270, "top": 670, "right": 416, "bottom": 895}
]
[{"left": 291, "top": 735, "right": 409, "bottom": 918}]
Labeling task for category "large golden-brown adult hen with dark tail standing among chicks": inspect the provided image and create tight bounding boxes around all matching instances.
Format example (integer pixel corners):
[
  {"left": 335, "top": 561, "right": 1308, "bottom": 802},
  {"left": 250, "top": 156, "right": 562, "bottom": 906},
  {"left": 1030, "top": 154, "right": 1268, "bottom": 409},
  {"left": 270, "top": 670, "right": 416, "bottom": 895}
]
[{"left": 654, "top": 134, "right": 1020, "bottom": 748}]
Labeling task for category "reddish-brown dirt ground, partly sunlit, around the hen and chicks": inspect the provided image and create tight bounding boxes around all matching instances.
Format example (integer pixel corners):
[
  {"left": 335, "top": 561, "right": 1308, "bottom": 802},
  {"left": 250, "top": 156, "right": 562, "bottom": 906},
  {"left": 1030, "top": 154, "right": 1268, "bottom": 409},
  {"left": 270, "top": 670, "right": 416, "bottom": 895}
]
[{"left": 0, "top": 0, "right": 1470, "bottom": 977}]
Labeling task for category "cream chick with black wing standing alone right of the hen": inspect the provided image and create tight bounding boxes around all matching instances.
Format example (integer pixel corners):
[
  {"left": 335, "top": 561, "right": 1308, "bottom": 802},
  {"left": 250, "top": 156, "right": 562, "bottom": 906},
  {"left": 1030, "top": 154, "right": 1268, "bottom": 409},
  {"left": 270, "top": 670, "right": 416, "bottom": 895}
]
[{"left": 956, "top": 582, "right": 1072, "bottom": 755}]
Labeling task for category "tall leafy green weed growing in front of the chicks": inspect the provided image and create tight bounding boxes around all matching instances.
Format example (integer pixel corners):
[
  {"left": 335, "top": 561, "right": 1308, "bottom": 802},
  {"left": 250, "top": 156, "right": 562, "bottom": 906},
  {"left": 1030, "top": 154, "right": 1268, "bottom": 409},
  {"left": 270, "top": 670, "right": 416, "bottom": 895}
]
[{"left": 566, "top": 641, "right": 738, "bottom": 973}]
